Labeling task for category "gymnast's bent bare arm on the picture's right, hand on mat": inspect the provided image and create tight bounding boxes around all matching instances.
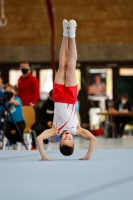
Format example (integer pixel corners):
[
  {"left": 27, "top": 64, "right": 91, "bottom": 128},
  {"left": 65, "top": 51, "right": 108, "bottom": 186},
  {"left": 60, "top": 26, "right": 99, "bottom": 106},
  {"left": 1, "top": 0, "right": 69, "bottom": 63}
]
[{"left": 77, "top": 125, "right": 96, "bottom": 160}]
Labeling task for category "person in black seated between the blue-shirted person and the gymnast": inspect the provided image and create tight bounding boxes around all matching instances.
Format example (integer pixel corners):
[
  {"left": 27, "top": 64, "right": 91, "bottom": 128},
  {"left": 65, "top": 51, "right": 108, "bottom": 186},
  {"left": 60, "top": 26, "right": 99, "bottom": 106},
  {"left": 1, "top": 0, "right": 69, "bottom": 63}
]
[{"left": 32, "top": 90, "right": 54, "bottom": 149}]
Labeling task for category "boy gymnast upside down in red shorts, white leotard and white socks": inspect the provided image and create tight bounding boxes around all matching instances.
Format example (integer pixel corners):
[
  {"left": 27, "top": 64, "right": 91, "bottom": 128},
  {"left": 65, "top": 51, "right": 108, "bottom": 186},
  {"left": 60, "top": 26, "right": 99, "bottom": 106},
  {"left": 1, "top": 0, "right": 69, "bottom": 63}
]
[{"left": 37, "top": 20, "right": 96, "bottom": 160}]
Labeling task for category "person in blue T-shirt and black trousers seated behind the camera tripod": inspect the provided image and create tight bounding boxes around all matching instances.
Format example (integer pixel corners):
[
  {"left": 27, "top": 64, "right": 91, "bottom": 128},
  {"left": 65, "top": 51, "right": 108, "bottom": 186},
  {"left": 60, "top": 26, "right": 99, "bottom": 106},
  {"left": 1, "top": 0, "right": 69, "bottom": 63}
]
[{"left": 0, "top": 84, "right": 25, "bottom": 150}]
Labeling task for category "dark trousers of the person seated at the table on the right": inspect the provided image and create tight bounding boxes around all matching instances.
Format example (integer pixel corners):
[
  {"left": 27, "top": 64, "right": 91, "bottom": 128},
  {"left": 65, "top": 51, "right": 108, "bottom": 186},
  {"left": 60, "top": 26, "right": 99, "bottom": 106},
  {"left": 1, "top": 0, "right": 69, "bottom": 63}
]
[{"left": 115, "top": 117, "right": 131, "bottom": 136}]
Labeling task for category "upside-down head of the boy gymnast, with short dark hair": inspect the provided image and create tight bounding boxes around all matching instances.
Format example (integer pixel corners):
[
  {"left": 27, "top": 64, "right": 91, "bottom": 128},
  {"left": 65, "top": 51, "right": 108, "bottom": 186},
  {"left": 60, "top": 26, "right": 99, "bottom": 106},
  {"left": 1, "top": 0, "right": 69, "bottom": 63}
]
[{"left": 60, "top": 130, "right": 74, "bottom": 156}]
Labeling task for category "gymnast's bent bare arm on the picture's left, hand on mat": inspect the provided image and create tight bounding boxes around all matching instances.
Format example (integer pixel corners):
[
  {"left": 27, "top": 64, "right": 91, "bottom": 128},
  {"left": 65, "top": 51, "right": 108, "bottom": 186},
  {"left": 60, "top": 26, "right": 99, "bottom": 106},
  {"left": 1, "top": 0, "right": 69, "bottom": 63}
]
[{"left": 36, "top": 125, "right": 56, "bottom": 160}]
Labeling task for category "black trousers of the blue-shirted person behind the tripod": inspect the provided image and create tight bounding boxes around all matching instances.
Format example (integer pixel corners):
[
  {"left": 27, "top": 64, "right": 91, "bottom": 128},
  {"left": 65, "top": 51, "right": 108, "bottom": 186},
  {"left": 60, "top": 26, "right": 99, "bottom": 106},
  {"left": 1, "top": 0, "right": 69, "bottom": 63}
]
[{"left": 5, "top": 121, "right": 25, "bottom": 144}]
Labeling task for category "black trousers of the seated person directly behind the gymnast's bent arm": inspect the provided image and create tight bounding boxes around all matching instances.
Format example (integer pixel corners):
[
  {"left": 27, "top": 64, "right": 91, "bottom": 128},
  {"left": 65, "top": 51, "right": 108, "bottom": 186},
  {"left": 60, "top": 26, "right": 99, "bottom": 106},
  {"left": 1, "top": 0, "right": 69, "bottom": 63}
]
[{"left": 31, "top": 123, "right": 49, "bottom": 147}]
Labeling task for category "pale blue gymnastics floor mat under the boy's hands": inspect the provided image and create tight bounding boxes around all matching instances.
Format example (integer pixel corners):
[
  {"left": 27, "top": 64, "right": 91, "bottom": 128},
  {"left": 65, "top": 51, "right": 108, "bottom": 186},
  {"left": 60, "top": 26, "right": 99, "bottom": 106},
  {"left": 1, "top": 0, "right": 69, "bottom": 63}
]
[{"left": 0, "top": 149, "right": 133, "bottom": 200}]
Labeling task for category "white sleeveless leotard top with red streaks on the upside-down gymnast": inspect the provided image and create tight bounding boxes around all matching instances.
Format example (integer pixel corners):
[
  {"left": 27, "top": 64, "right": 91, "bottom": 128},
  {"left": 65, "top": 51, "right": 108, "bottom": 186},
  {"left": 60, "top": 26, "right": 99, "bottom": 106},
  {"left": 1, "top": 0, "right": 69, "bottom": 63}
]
[{"left": 53, "top": 102, "right": 79, "bottom": 135}]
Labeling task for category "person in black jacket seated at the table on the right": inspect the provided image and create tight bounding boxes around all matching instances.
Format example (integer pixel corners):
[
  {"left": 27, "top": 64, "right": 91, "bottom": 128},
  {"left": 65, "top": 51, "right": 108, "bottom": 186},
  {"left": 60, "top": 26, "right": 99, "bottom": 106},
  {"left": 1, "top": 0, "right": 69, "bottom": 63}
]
[{"left": 114, "top": 93, "right": 132, "bottom": 137}]
